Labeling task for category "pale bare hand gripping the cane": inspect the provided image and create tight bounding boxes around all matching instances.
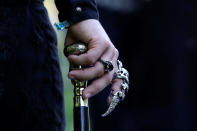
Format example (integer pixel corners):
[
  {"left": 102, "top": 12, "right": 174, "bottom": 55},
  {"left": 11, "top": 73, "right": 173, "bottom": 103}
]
[{"left": 65, "top": 19, "right": 122, "bottom": 102}]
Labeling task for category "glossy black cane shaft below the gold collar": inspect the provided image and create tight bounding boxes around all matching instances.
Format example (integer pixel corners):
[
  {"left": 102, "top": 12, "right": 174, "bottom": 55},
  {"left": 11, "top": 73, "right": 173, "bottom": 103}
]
[{"left": 74, "top": 106, "right": 90, "bottom": 131}]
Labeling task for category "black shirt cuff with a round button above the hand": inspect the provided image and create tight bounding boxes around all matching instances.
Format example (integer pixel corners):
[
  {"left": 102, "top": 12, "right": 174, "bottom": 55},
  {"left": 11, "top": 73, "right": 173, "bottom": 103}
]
[{"left": 55, "top": 0, "right": 99, "bottom": 23}]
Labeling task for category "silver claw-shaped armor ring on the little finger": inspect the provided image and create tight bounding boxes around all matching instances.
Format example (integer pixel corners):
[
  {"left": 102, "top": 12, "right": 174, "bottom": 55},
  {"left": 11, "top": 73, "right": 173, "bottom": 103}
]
[{"left": 102, "top": 60, "right": 129, "bottom": 117}]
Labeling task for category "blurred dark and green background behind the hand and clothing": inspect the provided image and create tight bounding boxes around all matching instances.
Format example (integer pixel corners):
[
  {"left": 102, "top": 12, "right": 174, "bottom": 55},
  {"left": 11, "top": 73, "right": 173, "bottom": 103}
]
[{"left": 45, "top": 0, "right": 197, "bottom": 131}]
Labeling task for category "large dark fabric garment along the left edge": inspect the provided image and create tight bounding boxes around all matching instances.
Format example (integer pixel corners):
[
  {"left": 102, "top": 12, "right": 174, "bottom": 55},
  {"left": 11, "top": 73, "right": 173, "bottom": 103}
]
[{"left": 0, "top": 0, "right": 65, "bottom": 131}]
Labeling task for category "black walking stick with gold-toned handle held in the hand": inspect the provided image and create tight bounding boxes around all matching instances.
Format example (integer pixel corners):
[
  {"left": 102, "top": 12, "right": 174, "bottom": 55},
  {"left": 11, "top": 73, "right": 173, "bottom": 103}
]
[{"left": 64, "top": 43, "right": 90, "bottom": 131}]
